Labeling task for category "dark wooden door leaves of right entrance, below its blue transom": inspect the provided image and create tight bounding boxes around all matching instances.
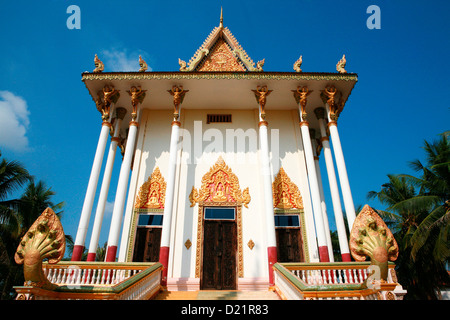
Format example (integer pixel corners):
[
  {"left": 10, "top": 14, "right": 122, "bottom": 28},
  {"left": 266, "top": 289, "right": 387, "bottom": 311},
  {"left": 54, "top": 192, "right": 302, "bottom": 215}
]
[{"left": 276, "top": 228, "right": 305, "bottom": 262}]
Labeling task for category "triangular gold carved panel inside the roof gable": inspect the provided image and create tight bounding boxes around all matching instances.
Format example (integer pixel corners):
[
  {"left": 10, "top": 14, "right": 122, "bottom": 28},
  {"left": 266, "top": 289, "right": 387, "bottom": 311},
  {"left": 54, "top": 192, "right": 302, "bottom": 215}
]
[{"left": 198, "top": 39, "right": 245, "bottom": 71}]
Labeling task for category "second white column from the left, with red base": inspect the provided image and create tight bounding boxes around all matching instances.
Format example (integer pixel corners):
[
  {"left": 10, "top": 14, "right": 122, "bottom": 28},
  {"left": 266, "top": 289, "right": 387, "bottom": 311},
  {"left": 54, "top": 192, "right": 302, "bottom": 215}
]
[{"left": 87, "top": 108, "right": 127, "bottom": 261}]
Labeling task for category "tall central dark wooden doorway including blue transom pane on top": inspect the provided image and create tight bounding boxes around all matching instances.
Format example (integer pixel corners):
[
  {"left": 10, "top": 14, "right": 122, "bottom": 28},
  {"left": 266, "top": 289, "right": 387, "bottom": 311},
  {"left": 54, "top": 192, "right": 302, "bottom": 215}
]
[{"left": 200, "top": 207, "right": 237, "bottom": 290}]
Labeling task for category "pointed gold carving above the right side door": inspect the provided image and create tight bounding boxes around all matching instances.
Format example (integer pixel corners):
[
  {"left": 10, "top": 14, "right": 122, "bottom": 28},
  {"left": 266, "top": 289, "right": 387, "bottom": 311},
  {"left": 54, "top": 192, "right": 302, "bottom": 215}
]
[{"left": 272, "top": 167, "right": 303, "bottom": 209}]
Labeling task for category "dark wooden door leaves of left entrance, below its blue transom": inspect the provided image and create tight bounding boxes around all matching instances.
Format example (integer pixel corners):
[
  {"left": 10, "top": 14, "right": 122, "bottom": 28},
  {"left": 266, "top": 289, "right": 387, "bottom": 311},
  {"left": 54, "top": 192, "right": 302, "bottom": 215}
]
[{"left": 133, "top": 228, "right": 162, "bottom": 262}]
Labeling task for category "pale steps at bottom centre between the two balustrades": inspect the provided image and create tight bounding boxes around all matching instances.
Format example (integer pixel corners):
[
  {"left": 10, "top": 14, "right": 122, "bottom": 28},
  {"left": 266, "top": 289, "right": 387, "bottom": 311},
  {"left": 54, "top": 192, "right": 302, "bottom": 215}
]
[{"left": 154, "top": 290, "right": 280, "bottom": 300}]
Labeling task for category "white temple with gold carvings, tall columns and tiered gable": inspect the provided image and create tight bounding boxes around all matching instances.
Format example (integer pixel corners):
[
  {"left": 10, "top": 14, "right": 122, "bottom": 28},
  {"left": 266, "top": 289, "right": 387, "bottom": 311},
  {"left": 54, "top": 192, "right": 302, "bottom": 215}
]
[{"left": 17, "top": 10, "right": 404, "bottom": 299}]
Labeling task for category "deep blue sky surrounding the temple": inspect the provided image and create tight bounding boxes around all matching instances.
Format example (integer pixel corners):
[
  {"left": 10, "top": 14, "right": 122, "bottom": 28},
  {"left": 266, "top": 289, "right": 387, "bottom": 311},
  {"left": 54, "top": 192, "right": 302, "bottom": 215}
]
[{"left": 0, "top": 0, "right": 450, "bottom": 255}]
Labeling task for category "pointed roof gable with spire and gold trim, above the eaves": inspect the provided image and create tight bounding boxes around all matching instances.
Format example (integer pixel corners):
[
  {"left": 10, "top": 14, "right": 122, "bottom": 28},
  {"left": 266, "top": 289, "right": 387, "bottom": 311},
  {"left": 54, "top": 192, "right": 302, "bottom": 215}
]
[{"left": 178, "top": 10, "right": 264, "bottom": 72}]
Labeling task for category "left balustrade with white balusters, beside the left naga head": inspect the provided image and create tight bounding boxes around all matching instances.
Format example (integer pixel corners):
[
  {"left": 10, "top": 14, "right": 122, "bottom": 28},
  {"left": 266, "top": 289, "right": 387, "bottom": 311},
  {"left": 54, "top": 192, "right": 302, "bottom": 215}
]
[{"left": 14, "top": 262, "right": 163, "bottom": 300}]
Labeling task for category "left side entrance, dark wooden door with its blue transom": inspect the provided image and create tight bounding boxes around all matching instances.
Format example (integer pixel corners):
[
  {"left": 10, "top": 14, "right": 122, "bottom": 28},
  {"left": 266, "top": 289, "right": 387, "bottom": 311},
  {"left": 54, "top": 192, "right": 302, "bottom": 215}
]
[{"left": 133, "top": 214, "right": 163, "bottom": 262}]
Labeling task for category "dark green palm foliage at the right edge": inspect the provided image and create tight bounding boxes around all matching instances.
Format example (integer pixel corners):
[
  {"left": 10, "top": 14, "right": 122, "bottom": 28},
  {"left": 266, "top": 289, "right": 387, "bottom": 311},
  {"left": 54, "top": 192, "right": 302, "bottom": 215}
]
[{"left": 368, "top": 133, "right": 450, "bottom": 299}]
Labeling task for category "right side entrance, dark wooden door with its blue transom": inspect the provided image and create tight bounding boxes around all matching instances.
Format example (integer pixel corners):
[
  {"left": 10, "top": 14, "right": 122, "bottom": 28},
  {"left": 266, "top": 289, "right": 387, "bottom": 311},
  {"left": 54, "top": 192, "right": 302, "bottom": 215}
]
[{"left": 275, "top": 214, "right": 305, "bottom": 262}]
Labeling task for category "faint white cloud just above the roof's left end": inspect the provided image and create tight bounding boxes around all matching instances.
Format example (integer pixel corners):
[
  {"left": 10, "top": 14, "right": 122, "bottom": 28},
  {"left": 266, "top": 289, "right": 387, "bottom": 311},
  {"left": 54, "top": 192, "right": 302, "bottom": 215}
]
[{"left": 99, "top": 49, "right": 152, "bottom": 72}]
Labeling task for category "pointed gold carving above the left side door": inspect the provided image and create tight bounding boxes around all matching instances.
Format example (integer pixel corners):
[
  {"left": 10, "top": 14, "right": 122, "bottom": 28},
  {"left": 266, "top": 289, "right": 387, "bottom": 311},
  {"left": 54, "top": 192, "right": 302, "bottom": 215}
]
[{"left": 134, "top": 167, "right": 166, "bottom": 209}]
